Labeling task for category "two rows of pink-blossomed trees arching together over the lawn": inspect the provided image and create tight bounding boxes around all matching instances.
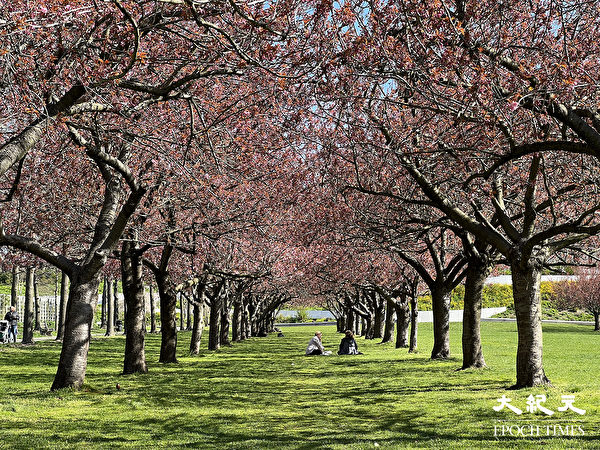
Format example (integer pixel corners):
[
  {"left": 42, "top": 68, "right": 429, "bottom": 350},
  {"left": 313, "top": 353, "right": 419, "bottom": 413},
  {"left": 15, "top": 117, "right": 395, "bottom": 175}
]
[{"left": 0, "top": 0, "right": 600, "bottom": 389}]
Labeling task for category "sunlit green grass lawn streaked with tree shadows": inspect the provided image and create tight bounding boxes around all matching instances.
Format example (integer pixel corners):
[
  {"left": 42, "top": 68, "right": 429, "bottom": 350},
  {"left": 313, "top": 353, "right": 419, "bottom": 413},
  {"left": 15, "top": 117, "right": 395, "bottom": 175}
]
[{"left": 0, "top": 322, "right": 600, "bottom": 449}]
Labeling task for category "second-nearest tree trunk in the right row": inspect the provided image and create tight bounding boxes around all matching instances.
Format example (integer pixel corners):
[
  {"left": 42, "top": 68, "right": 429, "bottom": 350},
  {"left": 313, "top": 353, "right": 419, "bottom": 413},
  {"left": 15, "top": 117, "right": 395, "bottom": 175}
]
[{"left": 462, "top": 261, "right": 488, "bottom": 369}]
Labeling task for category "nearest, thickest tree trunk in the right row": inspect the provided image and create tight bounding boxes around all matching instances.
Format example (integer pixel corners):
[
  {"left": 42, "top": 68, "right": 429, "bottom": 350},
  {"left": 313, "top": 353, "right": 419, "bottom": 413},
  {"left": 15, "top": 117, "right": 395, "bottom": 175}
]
[{"left": 511, "top": 264, "right": 550, "bottom": 389}]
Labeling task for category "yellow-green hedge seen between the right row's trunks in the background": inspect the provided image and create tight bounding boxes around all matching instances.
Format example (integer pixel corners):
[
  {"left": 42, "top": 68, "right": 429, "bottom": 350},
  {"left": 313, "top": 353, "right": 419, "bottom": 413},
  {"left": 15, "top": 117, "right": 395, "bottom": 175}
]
[{"left": 419, "top": 281, "right": 553, "bottom": 311}]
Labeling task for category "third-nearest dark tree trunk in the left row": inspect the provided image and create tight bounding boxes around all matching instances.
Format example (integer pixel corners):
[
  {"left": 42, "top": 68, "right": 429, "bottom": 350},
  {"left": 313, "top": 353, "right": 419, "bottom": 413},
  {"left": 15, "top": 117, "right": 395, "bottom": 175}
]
[{"left": 155, "top": 272, "right": 177, "bottom": 363}]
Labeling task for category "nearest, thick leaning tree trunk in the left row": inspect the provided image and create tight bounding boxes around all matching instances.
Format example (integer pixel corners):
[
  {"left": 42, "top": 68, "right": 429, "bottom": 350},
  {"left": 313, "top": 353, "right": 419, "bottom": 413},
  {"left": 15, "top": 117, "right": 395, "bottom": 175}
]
[{"left": 51, "top": 271, "right": 100, "bottom": 391}]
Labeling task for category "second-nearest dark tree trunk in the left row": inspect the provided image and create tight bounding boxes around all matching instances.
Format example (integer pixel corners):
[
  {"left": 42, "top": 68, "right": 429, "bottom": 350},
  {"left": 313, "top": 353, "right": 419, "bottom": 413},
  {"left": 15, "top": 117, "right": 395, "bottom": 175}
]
[{"left": 121, "top": 241, "right": 148, "bottom": 374}]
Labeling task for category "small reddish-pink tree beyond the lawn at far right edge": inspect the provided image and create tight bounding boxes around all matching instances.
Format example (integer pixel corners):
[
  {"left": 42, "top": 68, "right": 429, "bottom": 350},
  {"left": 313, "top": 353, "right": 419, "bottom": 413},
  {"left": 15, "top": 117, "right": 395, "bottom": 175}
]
[{"left": 554, "top": 268, "right": 600, "bottom": 331}]
